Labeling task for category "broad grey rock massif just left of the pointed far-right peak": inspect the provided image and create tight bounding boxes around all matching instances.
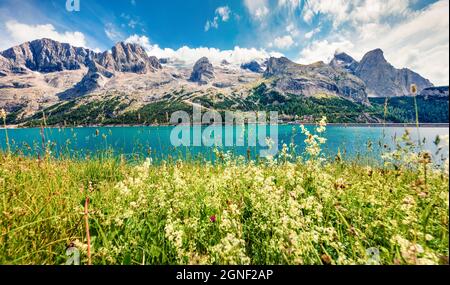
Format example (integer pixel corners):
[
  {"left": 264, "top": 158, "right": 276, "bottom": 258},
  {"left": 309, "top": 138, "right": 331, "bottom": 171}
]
[{"left": 264, "top": 57, "right": 368, "bottom": 103}]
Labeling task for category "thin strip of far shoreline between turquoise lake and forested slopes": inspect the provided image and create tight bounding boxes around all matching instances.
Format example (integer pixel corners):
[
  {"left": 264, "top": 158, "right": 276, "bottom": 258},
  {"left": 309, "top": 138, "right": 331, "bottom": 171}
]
[{"left": 0, "top": 122, "right": 450, "bottom": 130}]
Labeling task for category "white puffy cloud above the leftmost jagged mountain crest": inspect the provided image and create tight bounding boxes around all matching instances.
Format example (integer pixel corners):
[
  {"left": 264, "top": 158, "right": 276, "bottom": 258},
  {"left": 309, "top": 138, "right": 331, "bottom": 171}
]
[{"left": 2, "top": 21, "right": 88, "bottom": 48}]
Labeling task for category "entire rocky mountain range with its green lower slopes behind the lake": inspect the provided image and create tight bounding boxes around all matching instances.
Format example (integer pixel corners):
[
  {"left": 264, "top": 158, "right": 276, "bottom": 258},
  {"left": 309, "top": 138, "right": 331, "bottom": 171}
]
[{"left": 0, "top": 39, "right": 448, "bottom": 125}]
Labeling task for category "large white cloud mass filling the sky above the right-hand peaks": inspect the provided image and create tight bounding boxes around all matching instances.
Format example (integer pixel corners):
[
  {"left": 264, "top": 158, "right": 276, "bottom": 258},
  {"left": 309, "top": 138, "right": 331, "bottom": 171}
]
[{"left": 297, "top": 0, "right": 449, "bottom": 85}]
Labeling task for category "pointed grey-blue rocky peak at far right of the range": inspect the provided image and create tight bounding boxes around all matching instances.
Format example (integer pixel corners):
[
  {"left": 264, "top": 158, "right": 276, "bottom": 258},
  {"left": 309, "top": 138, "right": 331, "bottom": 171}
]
[{"left": 355, "top": 49, "right": 433, "bottom": 97}]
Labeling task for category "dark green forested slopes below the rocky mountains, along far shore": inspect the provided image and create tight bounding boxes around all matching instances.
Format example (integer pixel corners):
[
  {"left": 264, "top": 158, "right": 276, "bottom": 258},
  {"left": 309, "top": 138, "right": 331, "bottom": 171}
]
[{"left": 7, "top": 86, "right": 449, "bottom": 127}]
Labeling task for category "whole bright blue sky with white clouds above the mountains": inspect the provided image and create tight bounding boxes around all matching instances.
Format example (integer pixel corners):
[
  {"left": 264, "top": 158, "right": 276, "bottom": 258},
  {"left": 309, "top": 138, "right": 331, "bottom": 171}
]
[{"left": 0, "top": 0, "right": 449, "bottom": 84}]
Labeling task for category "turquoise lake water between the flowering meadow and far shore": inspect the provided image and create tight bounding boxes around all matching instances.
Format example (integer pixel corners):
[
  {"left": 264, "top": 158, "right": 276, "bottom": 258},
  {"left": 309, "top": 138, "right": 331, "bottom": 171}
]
[{"left": 0, "top": 125, "right": 449, "bottom": 163}]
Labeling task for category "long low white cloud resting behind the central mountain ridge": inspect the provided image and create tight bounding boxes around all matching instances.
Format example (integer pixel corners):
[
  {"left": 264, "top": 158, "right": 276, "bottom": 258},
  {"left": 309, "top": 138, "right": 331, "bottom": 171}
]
[{"left": 126, "top": 35, "right": 282, "bottom": 65}]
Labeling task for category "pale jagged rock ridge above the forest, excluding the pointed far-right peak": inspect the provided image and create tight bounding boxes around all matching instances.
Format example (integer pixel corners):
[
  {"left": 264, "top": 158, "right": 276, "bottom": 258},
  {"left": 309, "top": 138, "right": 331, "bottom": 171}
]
[{"left": 0, "top": 39, "right": 442, "bottom": 124}]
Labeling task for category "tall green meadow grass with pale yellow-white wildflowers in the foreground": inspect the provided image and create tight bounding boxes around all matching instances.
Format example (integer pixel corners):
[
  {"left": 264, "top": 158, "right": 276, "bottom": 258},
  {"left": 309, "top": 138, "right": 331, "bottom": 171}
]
[{"left": 0, "top": 120, "right": 449, "bottom": 265}]
